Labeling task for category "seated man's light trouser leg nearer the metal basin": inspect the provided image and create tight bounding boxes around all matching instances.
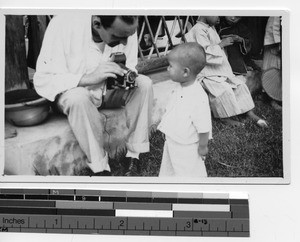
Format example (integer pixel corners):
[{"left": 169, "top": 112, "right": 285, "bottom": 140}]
[{"left": 57, "top": 87, "right": 110, "bottom": 173}]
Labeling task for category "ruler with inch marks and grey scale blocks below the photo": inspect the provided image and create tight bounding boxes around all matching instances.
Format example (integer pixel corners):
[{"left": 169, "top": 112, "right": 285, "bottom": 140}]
[{"left": 0, "top": 189, "right": 250, "bottom": 237}]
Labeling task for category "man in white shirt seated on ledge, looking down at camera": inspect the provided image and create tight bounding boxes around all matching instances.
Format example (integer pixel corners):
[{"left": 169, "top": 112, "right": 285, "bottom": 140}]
[{"left": 34, "top": 14, "right": 153, "bottom": 176}]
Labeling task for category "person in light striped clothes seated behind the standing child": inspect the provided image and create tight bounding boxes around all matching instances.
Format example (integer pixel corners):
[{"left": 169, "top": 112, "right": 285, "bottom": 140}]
[{"left": 186, "top": 16, "right": 268, "bottom": 127}]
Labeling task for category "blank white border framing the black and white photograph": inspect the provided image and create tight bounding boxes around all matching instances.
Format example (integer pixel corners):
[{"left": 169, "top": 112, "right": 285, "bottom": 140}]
[{"left": 0, "top": 8, "right": 291, "bottom": 184}]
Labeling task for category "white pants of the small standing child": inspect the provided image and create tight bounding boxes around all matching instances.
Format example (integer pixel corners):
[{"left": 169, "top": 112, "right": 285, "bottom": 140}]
[{"left": 159, "top": 137, "right": 207, "bottom": 177}]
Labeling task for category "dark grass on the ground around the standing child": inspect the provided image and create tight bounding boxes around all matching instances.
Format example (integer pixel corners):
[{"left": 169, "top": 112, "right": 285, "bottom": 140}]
[{"left": 111, "top": 93, "right": 283, "bottom": 177}]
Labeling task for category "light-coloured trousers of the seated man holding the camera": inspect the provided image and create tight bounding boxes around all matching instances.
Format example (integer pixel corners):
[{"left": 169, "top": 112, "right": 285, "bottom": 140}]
[{"left": 57, "top": 75, "right": 153, "bottom": 172}]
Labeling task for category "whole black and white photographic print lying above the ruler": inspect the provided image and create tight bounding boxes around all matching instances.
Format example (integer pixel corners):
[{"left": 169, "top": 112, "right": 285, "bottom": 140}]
[{"left": 1, "top": 10, "right": 290, "bottom": 183}]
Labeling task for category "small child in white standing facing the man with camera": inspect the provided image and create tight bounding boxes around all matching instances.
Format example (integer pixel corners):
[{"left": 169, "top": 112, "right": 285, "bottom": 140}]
[{"left": 158, "top": 43, "right": 211, "bottom": 177}]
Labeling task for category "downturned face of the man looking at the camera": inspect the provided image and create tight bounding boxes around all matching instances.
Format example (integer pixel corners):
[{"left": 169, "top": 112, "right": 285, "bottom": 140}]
[{"left": 92, "top": 16, "right": 138, "bottom": 47}]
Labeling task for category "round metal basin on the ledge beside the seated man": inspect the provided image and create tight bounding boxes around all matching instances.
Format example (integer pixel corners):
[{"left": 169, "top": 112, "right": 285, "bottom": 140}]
[{"left": 5, "top": 89, "right": 50, "bottom": 126}]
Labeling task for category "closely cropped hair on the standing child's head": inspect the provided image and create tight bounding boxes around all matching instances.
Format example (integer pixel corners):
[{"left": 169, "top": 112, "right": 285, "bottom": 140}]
[{"left": 170, "top": 42, "right": 206, "bottom": 75}]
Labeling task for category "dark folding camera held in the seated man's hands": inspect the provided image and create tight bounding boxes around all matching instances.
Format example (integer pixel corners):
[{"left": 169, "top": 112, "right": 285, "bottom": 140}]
[{"left": 106, "top": 52, "right": 137, "bottom": 89}]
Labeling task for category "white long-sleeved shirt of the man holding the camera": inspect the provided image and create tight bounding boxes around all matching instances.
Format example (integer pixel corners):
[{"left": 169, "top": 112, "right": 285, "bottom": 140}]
[{"left": 34, "top": 14, "right": 138, "bottom": 103}]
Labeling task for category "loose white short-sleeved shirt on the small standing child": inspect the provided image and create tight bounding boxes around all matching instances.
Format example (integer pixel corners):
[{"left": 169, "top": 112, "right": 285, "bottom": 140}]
[{"left": 158, "top": 81, "right": 212, "bottom": 144}]
